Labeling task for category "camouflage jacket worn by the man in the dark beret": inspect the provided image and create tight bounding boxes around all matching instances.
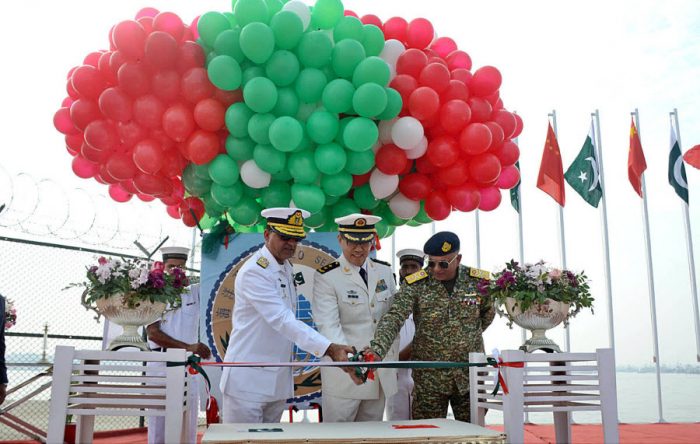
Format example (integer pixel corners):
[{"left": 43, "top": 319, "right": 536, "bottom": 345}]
[{"left": 370, "top": 266, "right": 495, "bottom": 393}]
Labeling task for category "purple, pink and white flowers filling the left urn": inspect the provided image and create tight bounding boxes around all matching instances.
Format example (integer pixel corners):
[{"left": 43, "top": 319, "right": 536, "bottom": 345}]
[{"left": 66, "top": 257, "right": 189, "bottom": 309}]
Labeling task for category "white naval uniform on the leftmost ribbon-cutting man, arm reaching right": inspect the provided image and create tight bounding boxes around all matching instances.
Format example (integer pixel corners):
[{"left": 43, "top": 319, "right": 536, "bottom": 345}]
[{"left": 220, "top": 246, "right": 330, "bottom": 423}]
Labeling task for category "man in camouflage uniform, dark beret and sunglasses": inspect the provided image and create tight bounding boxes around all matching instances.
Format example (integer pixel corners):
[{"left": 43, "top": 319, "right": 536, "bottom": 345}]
[{"left": 370, "top": 231, "right": 495, "bottom": 422}]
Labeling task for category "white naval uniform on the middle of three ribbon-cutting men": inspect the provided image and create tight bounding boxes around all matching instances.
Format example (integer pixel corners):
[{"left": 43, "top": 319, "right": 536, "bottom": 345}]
[{"left": 311, "top": 255, "right": 398, "bottom": 422}]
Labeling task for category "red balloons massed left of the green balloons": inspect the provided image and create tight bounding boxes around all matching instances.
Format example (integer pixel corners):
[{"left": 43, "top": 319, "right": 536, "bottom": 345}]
[{"left": 54, "top": 8, "right": 240, "bottom": 226}]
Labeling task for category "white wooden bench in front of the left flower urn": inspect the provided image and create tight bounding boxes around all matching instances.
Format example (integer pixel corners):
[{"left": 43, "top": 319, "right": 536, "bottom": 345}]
[{"left": 47, "top": 345, "right": 190, "bottom": 443}]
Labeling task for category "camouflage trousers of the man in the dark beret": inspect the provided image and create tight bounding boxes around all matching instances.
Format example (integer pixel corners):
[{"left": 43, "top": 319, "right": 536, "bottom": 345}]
[{"left": 411, "top": 383, "right": 470, "bottom": 422}]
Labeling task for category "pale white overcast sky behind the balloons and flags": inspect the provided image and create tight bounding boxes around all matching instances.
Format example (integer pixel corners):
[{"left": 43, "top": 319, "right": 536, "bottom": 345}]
[{"left": 0, "top": 0, "right": 700, "bottom": 365}]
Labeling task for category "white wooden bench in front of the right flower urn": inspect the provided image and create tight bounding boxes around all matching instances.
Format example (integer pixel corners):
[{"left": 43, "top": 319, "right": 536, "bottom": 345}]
[{"left": 469, "top": 348, "right": 619, "bottom": 443}]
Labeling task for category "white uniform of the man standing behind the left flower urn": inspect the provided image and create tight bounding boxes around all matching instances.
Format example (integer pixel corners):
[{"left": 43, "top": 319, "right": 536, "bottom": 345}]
[{"left": 148, "top": 284, "right": 201, "bottom": 444}]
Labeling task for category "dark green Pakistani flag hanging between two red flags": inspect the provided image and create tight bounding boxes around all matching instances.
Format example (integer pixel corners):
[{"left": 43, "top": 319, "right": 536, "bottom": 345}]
[{"left": 564, "top": 127, "right": 603, "bottom": 208}]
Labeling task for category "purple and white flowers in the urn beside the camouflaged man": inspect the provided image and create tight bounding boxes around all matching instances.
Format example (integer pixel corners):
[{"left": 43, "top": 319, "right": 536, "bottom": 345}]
[{"left": 484, "top": 260, "right": 594, "bottom": 325}]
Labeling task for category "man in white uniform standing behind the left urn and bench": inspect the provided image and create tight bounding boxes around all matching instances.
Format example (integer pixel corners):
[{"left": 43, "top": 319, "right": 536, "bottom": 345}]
[{"left": 146, "top": 247, "right": 206, "bottom": 444}]
